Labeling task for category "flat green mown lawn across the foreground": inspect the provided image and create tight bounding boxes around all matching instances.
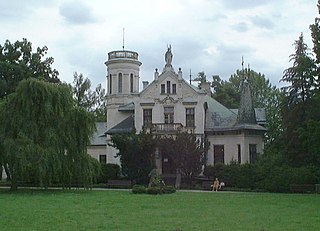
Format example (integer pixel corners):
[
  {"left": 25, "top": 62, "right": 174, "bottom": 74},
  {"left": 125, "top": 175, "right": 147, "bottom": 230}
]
[{"left": 0, "top": 189, "right": 320, "bottom": 231}]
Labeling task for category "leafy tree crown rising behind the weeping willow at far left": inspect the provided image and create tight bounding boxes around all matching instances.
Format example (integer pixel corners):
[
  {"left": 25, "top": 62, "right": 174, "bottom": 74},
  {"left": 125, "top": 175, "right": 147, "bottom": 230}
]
[{"left": 0, "top": 38, "right": 60, "bottom": 99}]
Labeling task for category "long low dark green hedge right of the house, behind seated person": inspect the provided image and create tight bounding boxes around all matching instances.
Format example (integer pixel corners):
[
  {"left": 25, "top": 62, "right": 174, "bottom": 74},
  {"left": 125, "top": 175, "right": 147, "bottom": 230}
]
[{"left": 204, "top": 163, "right": 320, "bottom": 192}]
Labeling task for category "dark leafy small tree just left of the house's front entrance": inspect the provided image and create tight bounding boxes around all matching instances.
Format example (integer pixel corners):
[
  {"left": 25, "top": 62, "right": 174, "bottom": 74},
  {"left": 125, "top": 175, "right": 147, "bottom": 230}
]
[{"left": 110, "top": 132, "right": 156, "bottom": 184}]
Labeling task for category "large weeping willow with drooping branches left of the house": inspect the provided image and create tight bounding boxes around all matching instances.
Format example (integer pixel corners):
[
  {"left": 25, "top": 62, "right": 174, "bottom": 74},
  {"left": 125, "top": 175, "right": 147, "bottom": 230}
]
[{"left": 0, "top": 78, "right": 99, "bottom": 189}]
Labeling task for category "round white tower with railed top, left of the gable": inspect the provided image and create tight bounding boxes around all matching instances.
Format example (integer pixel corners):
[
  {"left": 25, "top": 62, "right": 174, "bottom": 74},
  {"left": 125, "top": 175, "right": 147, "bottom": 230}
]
[{"left": 105, "top": 50, "right": 142, "bottom": 162}]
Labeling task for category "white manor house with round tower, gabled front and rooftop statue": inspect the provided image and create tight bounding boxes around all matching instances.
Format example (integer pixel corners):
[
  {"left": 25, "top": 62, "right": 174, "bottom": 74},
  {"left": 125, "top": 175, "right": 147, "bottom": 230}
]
[{"left": 88, "top": 47, "right": 266, "bottom": 174}]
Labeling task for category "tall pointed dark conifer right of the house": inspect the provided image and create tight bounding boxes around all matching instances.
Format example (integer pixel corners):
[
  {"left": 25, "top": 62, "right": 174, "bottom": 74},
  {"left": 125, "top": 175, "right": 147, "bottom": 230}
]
[{"left": 282, "top": 34, "right": 316, "bottom": 166}]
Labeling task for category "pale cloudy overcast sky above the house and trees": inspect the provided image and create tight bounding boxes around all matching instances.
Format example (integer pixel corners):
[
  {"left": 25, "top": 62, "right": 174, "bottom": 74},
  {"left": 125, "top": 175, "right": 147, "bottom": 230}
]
[{"left": 0, "top": 0, "right": 318, "bottom": 89}]
